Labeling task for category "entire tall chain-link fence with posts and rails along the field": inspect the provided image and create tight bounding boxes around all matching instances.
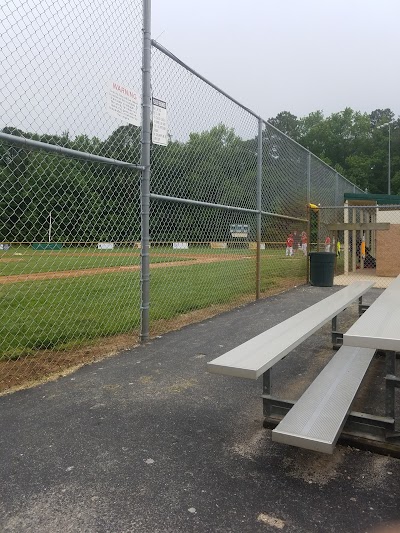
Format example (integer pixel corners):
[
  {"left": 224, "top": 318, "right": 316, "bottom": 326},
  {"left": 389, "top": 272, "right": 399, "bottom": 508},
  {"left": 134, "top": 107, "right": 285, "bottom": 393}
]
[{"left": 0, "top": 0, "right": 357, "bottom": 390}]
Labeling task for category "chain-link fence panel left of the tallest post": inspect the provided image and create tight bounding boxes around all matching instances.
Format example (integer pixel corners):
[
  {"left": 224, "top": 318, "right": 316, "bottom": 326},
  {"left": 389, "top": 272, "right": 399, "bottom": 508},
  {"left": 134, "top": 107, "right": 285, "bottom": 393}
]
[{"left": 0, "top": 0, "right": 142, "bottom": 389}]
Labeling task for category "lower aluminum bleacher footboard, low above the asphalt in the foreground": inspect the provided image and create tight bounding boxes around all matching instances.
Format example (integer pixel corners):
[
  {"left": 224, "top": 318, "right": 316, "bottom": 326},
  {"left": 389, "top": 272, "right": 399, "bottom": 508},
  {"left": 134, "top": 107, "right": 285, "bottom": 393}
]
[{"left": 272, "top": 346, "right": 375, "bottom": 453}]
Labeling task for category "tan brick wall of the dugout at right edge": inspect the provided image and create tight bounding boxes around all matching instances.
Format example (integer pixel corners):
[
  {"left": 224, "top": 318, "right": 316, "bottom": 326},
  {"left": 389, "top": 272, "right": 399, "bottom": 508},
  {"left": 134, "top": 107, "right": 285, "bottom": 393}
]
[{"left": 376, "top": 224, "right": 400, "bottom": 276}]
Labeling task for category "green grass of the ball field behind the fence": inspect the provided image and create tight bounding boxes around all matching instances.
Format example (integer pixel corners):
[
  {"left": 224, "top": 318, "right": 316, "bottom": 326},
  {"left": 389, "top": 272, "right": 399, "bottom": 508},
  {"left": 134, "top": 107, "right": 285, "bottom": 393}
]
[{"left": 0, "top": 247, "right": 306, "bottom": 359}]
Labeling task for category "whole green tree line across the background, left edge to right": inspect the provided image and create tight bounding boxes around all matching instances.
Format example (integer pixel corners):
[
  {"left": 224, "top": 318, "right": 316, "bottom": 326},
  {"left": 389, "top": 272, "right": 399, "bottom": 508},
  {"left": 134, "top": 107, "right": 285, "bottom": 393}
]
[{"left": 0, "top": 108, "right": 400, "bottom": 242}]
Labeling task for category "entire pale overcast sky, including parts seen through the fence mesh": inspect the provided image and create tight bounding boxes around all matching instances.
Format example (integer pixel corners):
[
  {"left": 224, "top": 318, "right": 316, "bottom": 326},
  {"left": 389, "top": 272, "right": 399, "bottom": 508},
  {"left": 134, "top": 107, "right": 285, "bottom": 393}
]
[{"left": 0, "top": 0, "right": 400, "bottom": 139}]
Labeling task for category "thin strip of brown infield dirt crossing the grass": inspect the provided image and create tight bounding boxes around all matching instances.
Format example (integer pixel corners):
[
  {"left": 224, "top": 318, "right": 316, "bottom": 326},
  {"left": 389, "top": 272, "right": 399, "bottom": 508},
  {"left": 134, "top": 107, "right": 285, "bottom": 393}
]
[{"left": 0, "top": 254, "right": 253, "bottom": 285}]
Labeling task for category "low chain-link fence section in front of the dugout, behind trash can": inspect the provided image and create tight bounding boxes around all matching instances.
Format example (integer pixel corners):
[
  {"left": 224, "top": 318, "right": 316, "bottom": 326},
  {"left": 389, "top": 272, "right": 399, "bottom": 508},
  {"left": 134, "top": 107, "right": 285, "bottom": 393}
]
[{"left": 318, "top": 200, "right": 400, "bottom": 288}]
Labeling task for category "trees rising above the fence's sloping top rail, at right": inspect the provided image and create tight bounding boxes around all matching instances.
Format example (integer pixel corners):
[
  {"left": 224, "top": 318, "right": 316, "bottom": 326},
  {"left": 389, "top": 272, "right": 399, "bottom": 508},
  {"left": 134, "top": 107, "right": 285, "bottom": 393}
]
[{"left": 269, "top": 107, "right": 400, "bottom": 194}]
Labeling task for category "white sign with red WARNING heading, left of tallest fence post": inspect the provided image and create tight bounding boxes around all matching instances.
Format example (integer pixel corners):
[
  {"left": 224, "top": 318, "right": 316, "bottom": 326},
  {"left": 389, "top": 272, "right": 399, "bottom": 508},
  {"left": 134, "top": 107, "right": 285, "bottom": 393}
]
[{"left": 107, "top": 81, "right": 140, "bottom": 126}]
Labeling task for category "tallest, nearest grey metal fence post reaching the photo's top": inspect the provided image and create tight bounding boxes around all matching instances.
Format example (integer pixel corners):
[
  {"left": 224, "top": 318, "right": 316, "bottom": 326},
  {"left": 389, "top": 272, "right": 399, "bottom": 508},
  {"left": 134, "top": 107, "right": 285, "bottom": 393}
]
[{"left": 140, "top": 0, "right": 151, "bottom": 342}]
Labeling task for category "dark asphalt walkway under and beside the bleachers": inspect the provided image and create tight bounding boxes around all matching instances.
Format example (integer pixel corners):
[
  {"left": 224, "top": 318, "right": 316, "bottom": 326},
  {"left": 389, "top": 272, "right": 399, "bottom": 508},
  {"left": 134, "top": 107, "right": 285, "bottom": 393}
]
[{"left": 0, "top": 287, "right": 400, "bottom": 533}]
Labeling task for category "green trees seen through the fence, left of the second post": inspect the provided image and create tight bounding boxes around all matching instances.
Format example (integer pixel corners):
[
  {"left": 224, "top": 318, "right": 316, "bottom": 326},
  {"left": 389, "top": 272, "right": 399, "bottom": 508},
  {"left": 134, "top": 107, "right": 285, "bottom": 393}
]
[{"left": 0, "top": 125, "right": 257, "bottom": 243}]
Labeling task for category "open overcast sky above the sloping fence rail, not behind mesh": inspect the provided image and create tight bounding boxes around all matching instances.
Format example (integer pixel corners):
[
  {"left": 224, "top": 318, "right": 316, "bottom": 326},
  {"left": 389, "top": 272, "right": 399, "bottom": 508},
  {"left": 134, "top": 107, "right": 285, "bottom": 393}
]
[{"left": 152, "top": 0, "right": 400, "bottom": 119}]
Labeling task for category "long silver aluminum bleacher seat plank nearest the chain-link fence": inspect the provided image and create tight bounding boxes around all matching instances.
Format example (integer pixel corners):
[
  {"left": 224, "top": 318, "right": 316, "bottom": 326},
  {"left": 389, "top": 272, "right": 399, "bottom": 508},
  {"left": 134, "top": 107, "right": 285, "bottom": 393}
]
[{"left": 207, "top": 281, "right": 374, "bottom": 379}]
